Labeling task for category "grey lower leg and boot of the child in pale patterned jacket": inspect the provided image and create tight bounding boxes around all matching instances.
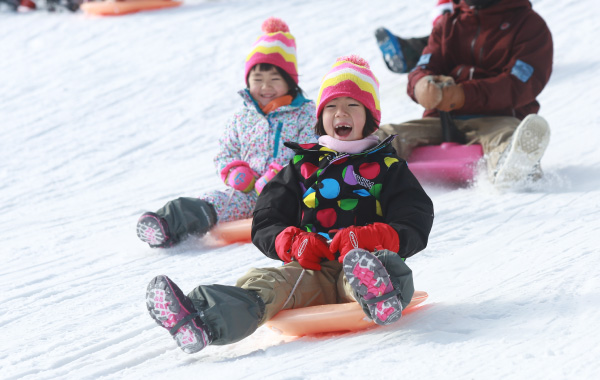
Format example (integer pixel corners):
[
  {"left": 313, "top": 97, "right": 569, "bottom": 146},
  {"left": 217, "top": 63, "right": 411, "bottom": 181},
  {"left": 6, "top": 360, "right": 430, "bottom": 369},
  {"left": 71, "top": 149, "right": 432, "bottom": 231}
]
[{"left": 137, "top": 197, "right": 217, "bottom": 247}]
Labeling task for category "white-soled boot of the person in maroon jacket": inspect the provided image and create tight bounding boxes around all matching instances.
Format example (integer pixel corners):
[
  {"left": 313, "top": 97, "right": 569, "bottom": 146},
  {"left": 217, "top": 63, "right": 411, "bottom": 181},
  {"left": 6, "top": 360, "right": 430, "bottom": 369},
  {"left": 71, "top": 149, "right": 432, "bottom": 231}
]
[{"left": 493, "top": 114, "right": 550, "bottom": 186}]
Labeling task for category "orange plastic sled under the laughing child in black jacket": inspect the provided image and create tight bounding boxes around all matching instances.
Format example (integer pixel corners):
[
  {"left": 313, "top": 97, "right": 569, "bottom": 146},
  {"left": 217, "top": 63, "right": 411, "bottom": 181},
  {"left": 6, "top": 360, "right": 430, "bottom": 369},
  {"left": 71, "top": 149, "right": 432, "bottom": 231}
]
[{"left": 266, "top": 290, "right": 428, "bottom": 336}]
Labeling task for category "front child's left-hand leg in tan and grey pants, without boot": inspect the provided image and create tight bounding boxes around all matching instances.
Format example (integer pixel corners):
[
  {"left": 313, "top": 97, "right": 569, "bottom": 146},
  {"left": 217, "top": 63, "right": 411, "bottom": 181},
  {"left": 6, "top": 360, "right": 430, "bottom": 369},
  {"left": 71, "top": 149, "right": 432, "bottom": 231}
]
[{"left": 162, "top": 261, "right": 341, "bottom": 348}]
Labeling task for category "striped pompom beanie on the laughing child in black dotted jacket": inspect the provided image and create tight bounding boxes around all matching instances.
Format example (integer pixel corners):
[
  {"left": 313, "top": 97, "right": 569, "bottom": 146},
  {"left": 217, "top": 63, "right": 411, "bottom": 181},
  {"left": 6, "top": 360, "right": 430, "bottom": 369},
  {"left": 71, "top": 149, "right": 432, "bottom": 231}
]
[{"left": 317, "top": 55, "right": 381, "bottom": 125}]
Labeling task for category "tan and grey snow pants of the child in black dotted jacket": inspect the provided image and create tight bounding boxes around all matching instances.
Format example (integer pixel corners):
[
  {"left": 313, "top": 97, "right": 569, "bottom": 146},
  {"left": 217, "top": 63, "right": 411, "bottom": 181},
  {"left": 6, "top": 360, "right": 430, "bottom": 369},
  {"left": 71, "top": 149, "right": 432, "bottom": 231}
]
[{"left": 188, "top": 250, "right": 414, "bottom": 345}]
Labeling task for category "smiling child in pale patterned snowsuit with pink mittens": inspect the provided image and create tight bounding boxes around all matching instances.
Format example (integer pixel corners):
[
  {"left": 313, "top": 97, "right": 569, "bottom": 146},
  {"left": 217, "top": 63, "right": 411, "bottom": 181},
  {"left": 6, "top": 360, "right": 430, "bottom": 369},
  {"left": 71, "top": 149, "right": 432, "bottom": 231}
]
[{"left": 137, "top": 17, "right": 316, "bottom": 248}]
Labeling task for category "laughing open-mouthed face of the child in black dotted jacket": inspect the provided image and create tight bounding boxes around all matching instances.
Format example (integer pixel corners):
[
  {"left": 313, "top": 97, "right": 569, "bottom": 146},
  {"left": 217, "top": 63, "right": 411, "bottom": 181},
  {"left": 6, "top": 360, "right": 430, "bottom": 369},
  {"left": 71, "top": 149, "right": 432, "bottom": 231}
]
[{"left": 322, "top": 97, "right": 367, "bottom": 141}]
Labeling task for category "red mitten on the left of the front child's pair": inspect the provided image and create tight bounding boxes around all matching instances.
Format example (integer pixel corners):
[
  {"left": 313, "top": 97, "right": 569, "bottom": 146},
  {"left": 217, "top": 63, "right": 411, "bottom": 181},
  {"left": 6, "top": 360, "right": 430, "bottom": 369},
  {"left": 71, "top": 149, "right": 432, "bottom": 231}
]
[{"left": 275, "top": 226, "right": 335, "bottom": 270}]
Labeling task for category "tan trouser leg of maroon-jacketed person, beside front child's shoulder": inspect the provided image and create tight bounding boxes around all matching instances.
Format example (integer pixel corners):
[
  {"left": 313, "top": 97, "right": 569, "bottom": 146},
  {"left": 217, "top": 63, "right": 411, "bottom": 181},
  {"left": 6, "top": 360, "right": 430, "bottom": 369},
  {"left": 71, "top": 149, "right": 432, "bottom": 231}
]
[{"left": 376, "top": 117, "right": 443, "bottom": 159}]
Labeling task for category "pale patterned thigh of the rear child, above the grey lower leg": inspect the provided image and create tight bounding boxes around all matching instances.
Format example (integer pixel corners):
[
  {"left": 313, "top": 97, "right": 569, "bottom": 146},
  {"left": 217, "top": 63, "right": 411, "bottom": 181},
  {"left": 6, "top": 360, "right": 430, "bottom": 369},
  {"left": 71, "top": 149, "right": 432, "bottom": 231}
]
[{"left": 200, "top": 188, "right": 258, "bottom": 222}]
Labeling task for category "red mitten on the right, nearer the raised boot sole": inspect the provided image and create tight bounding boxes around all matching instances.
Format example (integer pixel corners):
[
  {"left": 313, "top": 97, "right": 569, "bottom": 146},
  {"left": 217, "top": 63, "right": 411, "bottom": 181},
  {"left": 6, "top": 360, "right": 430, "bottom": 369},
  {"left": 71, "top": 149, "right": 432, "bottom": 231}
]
[{"left": 329, "top": 223, "right": 400, "bottom": 263}]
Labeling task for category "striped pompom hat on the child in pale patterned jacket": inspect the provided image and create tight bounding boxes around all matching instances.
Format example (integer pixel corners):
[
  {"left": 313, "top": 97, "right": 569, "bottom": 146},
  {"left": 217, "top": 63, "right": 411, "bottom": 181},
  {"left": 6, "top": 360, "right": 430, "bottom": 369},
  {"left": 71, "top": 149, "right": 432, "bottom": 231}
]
[{"left": 244, "top": 17, "right": 298, "bottom": 84}]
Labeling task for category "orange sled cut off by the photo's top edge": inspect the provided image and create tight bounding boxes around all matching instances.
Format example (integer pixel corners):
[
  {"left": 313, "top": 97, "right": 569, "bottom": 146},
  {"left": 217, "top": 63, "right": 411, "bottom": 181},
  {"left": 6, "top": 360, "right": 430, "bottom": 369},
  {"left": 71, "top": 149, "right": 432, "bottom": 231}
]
[{"left": 80, "top": 0, "right": 182, "bottom": 16}]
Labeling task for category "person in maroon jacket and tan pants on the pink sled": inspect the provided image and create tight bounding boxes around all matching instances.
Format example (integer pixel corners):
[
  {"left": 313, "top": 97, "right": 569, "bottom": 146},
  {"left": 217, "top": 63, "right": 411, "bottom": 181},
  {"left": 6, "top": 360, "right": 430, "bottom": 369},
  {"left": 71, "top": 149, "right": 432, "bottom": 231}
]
[{"left": 379, "top": 0, "right": 553, "bottom": 183}]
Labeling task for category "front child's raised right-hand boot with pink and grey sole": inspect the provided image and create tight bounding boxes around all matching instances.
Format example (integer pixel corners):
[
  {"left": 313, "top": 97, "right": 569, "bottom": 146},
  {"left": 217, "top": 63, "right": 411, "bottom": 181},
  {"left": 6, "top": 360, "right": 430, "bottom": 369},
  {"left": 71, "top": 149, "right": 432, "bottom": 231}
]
[{"left": 344, "top": 248, "right": 402, "bottom": 325}]
